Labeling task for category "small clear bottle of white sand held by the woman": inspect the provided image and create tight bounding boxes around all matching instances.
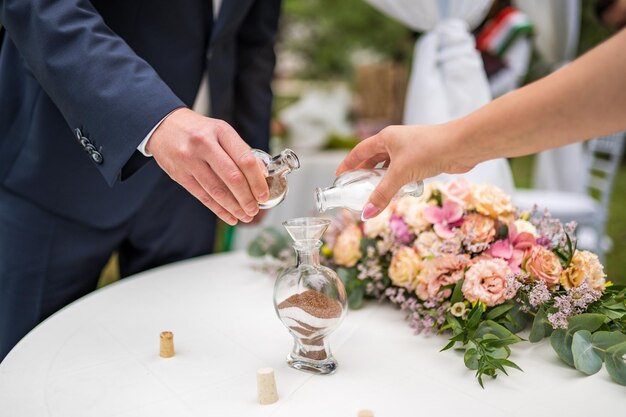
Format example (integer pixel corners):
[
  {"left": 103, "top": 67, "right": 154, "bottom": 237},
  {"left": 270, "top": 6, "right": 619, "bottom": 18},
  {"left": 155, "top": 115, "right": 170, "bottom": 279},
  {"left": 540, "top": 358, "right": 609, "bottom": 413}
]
[{"left": 315, "top": 168, "right": 424, "bottom": 216}]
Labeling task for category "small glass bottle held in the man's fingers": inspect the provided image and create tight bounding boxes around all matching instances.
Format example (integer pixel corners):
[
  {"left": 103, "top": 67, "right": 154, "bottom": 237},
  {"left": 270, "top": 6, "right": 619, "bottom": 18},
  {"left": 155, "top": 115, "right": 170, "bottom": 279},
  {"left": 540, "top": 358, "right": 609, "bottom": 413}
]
[{"left": 252, "top": 149, "right": 300, "bottom": 209}]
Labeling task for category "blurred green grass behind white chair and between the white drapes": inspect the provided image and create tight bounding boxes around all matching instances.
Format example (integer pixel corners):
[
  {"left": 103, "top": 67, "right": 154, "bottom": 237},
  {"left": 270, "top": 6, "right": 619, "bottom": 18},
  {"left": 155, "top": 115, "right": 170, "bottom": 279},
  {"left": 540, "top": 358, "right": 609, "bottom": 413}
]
[{"left": 511, "top": 156, "right": 626, "bottom": 284}]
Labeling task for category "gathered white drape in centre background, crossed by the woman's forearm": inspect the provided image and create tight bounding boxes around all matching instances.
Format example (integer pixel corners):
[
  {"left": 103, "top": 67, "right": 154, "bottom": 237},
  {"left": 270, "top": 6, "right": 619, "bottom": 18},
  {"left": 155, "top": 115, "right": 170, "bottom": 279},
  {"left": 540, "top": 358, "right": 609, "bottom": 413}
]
[{"left": 367, "top": 0, "right": 513, "bottom": 192}]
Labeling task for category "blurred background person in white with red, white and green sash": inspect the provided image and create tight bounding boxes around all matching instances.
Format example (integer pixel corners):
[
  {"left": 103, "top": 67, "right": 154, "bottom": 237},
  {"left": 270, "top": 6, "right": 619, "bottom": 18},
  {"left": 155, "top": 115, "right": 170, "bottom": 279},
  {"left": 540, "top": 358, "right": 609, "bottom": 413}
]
[{"left": 474, "top": 0, "right": 533, "bottom": 98}]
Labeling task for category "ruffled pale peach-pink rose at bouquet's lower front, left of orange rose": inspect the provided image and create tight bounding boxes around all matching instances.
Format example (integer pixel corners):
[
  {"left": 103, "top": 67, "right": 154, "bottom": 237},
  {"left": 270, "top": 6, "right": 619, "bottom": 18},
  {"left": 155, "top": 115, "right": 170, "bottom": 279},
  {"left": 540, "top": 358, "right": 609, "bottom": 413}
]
[{"left": 462, "top": 259, "right": 511, "bottom": 307}]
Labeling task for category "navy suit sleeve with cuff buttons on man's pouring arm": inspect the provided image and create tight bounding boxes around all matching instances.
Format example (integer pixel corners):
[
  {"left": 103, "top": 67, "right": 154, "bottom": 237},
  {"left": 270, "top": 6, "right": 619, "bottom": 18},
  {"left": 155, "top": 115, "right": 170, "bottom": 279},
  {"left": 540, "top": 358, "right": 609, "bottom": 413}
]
[{"left": 0, "top": 0, "right": 184, "bottom": 186}]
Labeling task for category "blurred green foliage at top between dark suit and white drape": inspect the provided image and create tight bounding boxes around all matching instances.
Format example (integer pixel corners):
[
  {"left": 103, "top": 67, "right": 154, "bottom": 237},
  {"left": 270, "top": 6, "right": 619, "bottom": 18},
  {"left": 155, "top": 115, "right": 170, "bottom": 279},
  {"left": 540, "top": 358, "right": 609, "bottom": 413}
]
[{"left": 279, "top": 0, "right": 413, "bottom": 79}]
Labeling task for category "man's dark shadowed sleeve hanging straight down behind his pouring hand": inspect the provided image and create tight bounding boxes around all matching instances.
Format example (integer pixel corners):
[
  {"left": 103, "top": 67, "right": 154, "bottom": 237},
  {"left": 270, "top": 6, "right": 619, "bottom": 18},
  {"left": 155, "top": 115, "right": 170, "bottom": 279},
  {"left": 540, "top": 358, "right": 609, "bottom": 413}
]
[{"left": 234, "top": 0, "right": 281, "bottom": 150}]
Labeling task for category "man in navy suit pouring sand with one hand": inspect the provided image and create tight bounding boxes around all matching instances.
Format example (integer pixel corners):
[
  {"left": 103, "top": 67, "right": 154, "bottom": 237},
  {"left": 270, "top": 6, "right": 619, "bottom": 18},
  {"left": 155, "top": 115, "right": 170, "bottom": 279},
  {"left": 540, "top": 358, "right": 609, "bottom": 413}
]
[{"left": 0, "top": 0, "right": 280, "bottom": 360}]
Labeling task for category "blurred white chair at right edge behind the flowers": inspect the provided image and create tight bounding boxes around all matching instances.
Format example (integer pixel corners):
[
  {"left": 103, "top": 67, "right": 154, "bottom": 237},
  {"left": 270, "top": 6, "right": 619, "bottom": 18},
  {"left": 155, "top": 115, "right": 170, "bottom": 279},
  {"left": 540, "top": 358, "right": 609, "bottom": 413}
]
[{"left": 513, "top": 132, "right": 624, "bottom": 260}]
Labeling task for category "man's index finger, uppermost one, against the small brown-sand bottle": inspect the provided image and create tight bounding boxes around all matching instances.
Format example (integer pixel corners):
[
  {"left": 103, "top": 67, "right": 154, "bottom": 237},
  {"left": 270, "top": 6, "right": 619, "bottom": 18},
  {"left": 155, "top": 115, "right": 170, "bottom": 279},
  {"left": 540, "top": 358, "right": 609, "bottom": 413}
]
[{"left": 217, "top": 124, "right": 269, "bottom": 203}]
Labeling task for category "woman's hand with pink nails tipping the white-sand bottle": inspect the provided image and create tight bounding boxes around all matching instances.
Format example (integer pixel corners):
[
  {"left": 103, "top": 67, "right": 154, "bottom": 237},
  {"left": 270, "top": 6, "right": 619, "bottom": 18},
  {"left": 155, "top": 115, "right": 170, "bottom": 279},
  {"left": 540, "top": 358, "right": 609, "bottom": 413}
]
[{"left": 337, "top": 123, "right": 475, "bottom": 219}]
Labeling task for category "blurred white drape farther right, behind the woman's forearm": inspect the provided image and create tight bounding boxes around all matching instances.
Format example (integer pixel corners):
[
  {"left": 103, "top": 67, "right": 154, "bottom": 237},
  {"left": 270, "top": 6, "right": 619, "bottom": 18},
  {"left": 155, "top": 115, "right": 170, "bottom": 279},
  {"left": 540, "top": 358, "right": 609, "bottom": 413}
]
[{"left": 516, "top": 0, "right": 587, "bottom": 193}]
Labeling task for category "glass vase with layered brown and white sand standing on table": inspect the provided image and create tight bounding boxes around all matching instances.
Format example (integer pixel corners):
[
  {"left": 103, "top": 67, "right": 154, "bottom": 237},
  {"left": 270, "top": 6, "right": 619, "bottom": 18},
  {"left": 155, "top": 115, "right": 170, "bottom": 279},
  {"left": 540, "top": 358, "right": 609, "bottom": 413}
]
[{"left": 274, "top": 217, "right": 347, "bottom": 374}]
